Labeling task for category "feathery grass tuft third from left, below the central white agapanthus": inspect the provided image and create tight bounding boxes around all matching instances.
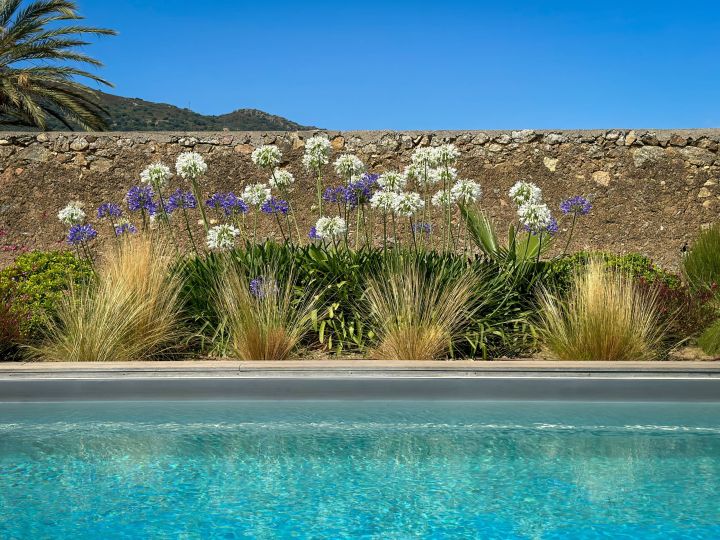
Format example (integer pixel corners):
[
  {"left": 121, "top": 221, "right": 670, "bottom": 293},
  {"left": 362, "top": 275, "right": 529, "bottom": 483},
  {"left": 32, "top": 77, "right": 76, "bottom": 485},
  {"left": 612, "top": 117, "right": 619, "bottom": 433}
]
[{"left": 366, "top": 258, "right": 477, "bottom": 360}]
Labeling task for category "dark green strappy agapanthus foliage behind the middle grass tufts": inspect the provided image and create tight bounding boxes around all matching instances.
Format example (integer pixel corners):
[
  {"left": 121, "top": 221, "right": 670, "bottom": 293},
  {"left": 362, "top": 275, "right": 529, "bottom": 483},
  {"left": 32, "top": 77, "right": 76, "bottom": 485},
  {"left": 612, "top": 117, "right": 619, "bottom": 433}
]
[{"left": 178, "top": 242, "right": 544, "bottom": 357}]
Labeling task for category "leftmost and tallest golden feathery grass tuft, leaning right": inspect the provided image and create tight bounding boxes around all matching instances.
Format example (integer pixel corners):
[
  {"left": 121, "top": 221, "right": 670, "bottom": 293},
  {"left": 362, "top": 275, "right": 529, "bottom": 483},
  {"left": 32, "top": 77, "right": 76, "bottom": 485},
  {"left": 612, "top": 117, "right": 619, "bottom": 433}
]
[{"left": 31, "top": 236, "right": 182, "bottom": 362}]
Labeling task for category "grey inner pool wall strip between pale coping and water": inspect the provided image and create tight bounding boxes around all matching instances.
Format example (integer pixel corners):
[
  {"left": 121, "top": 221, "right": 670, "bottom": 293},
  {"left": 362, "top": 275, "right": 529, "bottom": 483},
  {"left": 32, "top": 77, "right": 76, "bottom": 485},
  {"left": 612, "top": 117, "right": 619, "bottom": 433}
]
[{"left": 0, "top": 375, "right": 720, "bottom": 402}]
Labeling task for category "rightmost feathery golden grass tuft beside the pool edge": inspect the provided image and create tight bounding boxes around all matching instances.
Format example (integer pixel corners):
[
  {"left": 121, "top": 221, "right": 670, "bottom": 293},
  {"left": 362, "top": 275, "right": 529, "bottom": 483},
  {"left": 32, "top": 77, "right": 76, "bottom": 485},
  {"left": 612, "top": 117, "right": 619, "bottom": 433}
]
[{"left": 539, "top": 260, "right": 663, "bottom": 360}]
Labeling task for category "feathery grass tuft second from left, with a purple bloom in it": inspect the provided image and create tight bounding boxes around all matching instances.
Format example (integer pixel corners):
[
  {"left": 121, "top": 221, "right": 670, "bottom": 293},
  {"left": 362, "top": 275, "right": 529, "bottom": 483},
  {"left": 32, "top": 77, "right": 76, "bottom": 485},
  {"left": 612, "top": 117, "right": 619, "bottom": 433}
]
[{"left": 216, "top": 263, "right": 316, "bottom": 360}]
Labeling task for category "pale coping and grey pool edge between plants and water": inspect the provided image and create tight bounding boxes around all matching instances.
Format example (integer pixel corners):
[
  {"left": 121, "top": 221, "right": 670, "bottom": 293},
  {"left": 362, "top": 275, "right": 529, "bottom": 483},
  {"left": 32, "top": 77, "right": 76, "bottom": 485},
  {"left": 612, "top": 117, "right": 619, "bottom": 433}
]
[{"left": 0, "top": 360, "right": 720, "bottom": 402}]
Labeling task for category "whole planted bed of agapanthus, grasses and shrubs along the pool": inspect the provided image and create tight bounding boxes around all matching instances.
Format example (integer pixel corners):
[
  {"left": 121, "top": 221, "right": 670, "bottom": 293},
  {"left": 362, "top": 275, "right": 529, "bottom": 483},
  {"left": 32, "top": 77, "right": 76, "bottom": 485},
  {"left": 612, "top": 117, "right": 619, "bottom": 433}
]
[{"left": 0, "top": 136, "right": 720, "bottom": 362}]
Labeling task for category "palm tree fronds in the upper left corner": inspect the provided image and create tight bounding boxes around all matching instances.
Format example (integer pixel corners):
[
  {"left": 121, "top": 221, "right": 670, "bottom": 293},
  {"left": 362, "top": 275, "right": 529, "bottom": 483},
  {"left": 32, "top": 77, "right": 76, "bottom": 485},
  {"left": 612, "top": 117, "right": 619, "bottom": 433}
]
[{"left": 0, "top": 0, "right": 115, "bottom": 131}]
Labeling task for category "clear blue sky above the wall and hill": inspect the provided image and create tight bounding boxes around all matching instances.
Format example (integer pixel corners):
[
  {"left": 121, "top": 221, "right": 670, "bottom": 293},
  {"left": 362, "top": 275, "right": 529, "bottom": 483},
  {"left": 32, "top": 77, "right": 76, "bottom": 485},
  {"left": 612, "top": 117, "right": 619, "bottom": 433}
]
[{"left": 78, "top": 0, "right": 720, "bottom": 129}]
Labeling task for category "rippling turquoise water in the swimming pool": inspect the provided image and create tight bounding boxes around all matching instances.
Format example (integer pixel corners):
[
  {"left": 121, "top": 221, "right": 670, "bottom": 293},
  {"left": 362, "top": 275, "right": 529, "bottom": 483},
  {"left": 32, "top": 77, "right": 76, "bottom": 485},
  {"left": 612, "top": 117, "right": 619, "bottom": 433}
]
[{"left": 0, "top": 402, "right": 720, "bottom": 540}]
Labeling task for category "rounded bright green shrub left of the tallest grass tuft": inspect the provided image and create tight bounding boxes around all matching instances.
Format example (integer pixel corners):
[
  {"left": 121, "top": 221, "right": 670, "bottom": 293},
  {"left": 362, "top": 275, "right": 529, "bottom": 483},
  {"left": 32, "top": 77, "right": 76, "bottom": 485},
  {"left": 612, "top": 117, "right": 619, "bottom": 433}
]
[{"left": 0, "top": 251, "right": 92, "bottom": 341}]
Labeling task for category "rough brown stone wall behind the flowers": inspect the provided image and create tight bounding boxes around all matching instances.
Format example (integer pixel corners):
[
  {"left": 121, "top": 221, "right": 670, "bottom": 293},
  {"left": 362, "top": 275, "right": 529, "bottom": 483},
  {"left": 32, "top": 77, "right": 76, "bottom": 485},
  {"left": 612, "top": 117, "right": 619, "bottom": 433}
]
[{"left": 0, "top": 130, "right": 720, "bottom": 267}]
